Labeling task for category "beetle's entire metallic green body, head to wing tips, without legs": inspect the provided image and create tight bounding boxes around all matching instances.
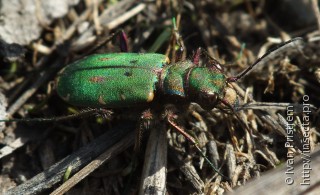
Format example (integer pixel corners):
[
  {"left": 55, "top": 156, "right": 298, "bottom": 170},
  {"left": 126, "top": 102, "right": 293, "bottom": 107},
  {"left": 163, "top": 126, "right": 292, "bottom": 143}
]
[{"left": 57, "top": 53, "right": 233, "bottom": 108}]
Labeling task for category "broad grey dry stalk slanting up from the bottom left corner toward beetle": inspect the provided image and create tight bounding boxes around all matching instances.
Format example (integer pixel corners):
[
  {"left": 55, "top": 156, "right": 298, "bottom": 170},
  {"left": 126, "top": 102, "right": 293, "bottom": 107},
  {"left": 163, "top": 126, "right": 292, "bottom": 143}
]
[{"left": 6, "top": 126, "right": 134, "bottom": 195}]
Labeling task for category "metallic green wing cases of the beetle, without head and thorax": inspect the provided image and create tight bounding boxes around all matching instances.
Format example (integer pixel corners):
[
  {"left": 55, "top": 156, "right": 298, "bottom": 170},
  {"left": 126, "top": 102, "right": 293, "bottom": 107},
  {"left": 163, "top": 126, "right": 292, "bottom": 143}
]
[{"left": 57, "top": 53, "right": 166, "bottom": 108}]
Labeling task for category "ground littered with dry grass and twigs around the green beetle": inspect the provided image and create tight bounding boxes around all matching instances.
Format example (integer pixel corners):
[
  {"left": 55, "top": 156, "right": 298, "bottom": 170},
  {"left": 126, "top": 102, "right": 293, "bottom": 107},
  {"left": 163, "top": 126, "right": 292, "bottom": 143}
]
[{"left": 0, "top": 0, "right": 320, "bottom": 195}]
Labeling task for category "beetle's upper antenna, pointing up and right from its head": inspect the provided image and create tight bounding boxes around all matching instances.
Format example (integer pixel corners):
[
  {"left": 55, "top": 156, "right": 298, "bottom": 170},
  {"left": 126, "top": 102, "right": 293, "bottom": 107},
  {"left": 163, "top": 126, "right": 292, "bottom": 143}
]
[{"left": 227, "top": 37, "right": 304, "bottom": 82}]
